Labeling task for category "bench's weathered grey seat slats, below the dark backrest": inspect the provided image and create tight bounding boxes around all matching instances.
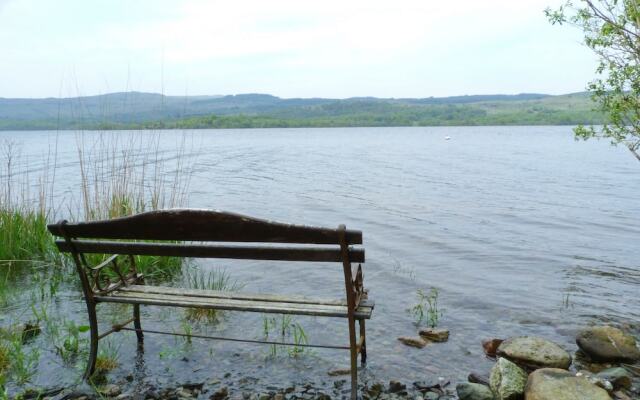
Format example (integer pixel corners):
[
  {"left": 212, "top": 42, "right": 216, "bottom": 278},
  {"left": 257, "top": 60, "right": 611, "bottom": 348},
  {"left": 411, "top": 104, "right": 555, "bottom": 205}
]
[{"left": 94, "top": 287, "right": 373, "bottom": 319}]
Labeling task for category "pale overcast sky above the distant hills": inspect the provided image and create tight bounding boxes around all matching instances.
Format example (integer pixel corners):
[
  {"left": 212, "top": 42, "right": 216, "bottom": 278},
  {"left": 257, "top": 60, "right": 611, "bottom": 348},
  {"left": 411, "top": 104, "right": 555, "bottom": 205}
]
[{"left": 0, "top": 0, "right": 595, "bottom": 98}]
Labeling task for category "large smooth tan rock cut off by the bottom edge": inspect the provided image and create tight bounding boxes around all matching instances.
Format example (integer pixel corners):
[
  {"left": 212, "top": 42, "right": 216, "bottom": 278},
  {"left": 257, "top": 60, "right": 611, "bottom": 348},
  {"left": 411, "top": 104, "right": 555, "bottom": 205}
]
[{"left": 525, "top": 368, "right": 611, "bottom": 400}]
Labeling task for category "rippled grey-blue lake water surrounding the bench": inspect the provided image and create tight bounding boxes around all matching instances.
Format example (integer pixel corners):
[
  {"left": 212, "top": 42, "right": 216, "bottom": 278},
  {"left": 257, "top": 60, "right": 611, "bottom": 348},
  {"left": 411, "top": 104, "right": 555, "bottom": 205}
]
[{"left": 0, "top": 127, "right": 640, "bottom": 396}]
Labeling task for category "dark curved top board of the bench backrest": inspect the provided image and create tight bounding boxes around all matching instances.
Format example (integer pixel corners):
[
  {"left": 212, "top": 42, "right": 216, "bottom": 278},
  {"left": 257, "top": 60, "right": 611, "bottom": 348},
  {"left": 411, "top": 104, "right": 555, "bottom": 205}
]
[{"left": 48, "top": 209, "right": 362, "bottom": 244}]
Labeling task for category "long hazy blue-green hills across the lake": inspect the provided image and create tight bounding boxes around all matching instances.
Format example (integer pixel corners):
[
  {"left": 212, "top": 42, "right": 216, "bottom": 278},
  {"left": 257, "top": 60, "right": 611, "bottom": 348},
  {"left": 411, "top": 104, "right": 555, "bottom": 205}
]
[{"left": 0, "top": 92, "right": 602, "bottom": 130}]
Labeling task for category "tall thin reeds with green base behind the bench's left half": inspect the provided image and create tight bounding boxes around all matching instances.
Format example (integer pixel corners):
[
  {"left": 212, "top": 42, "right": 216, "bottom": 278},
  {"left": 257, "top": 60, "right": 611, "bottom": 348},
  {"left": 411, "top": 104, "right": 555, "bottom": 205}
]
[{"left": 72, "top": 135, "right": 195, "bottom": 282}]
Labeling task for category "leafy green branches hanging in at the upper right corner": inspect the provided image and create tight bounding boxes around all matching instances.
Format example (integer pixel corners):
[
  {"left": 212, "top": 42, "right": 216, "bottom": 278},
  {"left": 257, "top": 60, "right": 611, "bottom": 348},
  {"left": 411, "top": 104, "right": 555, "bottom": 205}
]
[{"left": 546, "top": 0, "right": 640, "bottom": 161}]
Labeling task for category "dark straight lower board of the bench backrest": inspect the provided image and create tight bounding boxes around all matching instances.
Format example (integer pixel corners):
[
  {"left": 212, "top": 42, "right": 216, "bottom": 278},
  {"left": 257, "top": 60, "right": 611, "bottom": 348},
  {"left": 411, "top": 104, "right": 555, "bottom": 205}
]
[{"left": 56, "top": 240, "right": 364, "bottom": 262}]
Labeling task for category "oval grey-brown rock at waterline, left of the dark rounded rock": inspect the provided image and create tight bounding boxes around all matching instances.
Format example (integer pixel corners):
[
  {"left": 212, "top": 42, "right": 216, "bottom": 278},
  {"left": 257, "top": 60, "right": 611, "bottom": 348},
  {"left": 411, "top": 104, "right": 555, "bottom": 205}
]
[{"left": 496, "top": 336, "right": 571, "bottom": 369}]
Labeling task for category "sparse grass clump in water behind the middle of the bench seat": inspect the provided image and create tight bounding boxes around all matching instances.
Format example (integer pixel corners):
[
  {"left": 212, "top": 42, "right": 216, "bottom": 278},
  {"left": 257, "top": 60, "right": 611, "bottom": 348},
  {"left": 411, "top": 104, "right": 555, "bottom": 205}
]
[{"left": 184, "top": 268, "right": 244, "bottom": 322}]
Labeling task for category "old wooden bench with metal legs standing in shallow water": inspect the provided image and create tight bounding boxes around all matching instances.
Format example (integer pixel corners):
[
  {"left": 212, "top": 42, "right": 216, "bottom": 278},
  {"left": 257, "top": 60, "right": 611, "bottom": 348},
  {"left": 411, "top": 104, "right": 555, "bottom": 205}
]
[{"left": 48, "top": 209, "right": 374, "bottom": 399}]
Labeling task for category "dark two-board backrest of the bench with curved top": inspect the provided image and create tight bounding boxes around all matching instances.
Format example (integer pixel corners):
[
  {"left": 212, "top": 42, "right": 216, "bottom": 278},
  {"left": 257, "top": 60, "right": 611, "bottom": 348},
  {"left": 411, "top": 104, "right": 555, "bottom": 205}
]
[{"left": 48, "top": 209, "right": 364, "bottom": 262}]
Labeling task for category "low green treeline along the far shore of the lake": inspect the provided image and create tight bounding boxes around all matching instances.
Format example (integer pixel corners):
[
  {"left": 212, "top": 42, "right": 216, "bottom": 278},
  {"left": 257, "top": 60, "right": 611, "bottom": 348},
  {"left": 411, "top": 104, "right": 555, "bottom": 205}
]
[{"left": 0, "top": 103, "right": 604, "bottom": 130}]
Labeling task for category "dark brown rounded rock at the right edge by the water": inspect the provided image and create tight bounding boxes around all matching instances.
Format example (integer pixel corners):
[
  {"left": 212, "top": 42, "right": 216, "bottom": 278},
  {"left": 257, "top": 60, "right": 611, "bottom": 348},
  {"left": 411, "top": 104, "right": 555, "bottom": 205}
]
[{"left": 576, "top": 326, "right": 640, "bottom": 363}]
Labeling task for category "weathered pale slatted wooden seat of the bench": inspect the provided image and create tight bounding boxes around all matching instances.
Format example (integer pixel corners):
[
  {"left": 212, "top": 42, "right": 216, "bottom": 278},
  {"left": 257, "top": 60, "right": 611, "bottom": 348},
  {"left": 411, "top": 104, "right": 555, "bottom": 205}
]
[{"left": 95, "top": 292, "right": 372, "bottom": 319}]
